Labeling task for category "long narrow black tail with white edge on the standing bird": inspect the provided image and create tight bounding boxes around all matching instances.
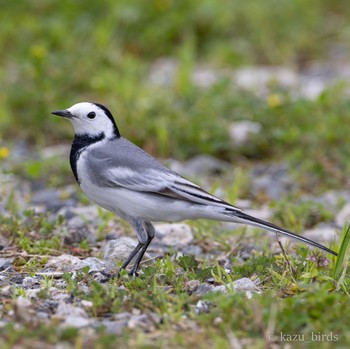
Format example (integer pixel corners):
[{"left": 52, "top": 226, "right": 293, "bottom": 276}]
[{"left": 225, "top": 209, "right": 338, "bottom": 256}]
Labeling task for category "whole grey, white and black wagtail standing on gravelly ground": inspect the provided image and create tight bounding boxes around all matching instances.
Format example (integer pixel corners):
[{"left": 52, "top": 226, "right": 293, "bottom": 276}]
[{"left": 52, "top": 102, "right": 337, "bottom": 275}]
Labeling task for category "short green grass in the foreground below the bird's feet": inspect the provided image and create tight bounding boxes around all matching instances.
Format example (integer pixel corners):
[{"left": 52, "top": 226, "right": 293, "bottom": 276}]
[{"left": 0, "top": 238, "right": 350, "bottom": 348}]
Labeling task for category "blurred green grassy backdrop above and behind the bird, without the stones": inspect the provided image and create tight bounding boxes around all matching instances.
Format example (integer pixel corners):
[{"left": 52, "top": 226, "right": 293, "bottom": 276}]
[{"left": 0, "top": 0, "right": 350, "bottom": 185}]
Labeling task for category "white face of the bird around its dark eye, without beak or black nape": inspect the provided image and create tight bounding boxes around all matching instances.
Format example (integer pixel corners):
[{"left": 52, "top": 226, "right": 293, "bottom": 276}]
[{"left": 67, "top": 102, "right": 114, "bottom": 138}]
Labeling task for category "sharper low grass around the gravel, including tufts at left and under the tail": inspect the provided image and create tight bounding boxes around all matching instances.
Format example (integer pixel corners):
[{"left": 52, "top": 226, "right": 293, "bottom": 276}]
[{"left": 0, "top": 194, "right": 350, "bottom": 348}]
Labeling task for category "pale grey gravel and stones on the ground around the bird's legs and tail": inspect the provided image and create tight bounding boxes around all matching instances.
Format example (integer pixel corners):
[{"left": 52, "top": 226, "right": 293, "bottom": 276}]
[{"left": 0, "top": 142, "right": 344, "bottom": 334}]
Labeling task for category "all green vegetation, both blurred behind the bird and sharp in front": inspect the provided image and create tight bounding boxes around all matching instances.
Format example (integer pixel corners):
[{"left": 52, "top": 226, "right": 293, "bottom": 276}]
[{"left": 0, "top": 0, "right": 350, "bottom": 349}]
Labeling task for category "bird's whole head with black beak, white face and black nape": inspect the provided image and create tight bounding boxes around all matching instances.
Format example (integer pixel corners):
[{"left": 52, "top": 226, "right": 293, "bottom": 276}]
[{"left": 52, "top": 102, "right": 120, "bottom": 138}]
